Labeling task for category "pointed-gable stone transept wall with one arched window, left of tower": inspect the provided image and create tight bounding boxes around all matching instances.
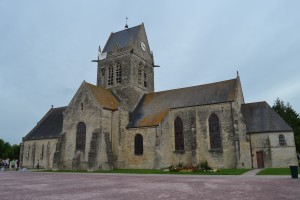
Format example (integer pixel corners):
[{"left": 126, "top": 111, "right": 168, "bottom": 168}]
[{"left": 58, "top": 85, "right": 117, "bottom": 170}]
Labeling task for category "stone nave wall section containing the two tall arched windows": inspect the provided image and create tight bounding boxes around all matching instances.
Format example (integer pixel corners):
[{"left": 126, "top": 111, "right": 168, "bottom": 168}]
[{"left": 162, "top": 103, "right": 236, "bottom": 168}]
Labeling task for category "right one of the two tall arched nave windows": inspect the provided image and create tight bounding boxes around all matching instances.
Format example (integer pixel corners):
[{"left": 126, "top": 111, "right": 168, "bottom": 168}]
[{"left": 208, "top": 113, "right": 222, "bottom": 149}]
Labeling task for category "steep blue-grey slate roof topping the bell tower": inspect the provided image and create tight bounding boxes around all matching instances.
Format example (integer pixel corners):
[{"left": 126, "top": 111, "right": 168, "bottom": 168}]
[{"left": 102, "top": 25, "right": 141, "bottom": 53}]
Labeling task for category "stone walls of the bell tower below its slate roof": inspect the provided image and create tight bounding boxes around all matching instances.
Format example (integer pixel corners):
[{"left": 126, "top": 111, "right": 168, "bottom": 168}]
[{"left": 97, "top": 36, "right": 154, "bottom": 111}]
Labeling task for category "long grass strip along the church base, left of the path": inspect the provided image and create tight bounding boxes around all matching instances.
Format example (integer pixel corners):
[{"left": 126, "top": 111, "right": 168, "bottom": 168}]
[{"left": 39, "top": 169, "right": 250, "bottom": 175}]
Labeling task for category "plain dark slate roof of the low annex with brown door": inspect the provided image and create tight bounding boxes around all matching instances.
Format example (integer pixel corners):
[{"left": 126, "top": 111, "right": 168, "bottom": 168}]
[{"left": 242, "top": 101, "right": 293, "bottom": 133}]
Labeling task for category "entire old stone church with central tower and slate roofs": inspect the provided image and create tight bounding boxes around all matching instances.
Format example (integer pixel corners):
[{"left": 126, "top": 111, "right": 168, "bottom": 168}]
[{"left": 20, "top": 24, "right": 297, "bottom": 170}]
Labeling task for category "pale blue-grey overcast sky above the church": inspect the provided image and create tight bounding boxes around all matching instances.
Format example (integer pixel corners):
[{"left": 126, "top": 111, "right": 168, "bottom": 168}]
[{"left": 0, "top": 0, "right": 300, "bottom": 144}]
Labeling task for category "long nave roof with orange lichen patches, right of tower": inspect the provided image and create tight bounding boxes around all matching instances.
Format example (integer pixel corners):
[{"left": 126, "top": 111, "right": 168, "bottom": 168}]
[{"left": 128, "top": 79, "right": 237, "bottom": 128}]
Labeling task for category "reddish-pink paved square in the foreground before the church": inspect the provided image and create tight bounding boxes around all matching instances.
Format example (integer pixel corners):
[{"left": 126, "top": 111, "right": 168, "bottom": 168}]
[{"left": 0, "top": 172, "right": 300, "bottom": 200}]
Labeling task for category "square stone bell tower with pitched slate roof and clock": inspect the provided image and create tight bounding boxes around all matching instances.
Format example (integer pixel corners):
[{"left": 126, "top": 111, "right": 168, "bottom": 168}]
[{"left": 97, "top": 24, "right": 154, "bottom": 111}]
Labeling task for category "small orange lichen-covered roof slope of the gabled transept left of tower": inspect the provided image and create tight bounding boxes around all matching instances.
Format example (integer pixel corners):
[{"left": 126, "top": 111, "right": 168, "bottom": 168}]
[{"left": 86, "top": 83, "right": 119, "bottom": 110}]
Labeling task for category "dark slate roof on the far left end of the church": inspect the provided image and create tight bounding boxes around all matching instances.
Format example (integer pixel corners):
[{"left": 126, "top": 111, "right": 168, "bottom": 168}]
[{"left": 23, "top": 107, "right": 67, "bottom": 140}]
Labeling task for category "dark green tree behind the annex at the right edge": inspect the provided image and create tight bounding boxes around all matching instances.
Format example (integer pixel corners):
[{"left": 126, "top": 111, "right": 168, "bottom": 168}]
[{"left": 272, "top": 98, "right": 300, "bottom": 152}]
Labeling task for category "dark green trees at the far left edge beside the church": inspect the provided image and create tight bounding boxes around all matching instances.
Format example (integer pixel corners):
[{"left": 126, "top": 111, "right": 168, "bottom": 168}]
[{"left": 0, "top": 139, "right": 20, "bottom": 159}]
